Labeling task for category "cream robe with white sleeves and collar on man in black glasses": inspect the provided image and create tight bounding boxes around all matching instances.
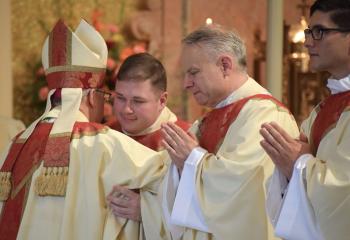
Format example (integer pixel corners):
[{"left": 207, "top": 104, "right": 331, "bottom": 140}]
[{"left": 267, "top": 76, "right": 350, "bottom": 240}]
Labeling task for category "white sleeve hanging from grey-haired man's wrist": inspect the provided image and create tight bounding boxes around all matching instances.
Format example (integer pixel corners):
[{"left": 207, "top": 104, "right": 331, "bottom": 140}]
[{"left": 171, "top": 147, "right": 209, "bottom": 232}]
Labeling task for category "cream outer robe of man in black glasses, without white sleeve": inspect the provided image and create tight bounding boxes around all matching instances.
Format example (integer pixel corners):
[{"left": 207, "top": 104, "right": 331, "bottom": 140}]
[{"left": 302, "top": 109, "right": 350, "bottom": 240}]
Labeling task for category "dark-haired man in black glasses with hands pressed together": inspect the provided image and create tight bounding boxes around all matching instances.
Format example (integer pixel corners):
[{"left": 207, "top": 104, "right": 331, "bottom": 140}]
[{"left": 260, "top": 0, "right": 350, "bottom": 240}]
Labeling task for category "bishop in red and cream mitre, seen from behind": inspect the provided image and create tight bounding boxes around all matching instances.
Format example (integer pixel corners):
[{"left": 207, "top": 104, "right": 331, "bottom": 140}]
[{"left": 0, "top": 20, "right": 164, "bottom": 240}]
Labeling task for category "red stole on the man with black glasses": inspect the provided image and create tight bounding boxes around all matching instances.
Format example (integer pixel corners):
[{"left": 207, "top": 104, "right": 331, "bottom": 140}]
[{"left": 310, "top": 91, "right": 350, "bottom": 155}]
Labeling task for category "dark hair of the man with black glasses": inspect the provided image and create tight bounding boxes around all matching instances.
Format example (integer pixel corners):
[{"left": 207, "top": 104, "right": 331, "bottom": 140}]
[{"left": 310, "top": 0, "right": 350, "bottom": 28}]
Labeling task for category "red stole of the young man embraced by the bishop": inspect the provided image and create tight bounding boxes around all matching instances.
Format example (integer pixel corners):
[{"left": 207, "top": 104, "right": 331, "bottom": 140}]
[{"left": 111, "top": 120, "right": 190, "bottom": 151}]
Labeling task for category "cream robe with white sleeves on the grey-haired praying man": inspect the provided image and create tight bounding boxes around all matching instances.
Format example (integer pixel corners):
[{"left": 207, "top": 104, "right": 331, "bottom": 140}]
[{"left": 161, "top": 79, "right": 298, "bottom": 240}]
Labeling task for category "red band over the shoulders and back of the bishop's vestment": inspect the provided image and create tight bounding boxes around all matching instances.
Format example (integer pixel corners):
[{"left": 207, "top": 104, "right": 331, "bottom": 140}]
[{"left": 0, "top": 122, "right": 105, "bottom": 240}]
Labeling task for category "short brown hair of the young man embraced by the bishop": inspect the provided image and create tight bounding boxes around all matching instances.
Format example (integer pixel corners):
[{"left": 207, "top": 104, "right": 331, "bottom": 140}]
[{"left": 117, "top": 53, "right": 167, "bottom": 91}]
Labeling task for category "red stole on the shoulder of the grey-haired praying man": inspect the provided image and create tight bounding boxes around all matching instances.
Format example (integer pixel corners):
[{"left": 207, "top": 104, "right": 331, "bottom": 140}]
[{"left": 198, "top": 94, "right": 286, "bottom": 153}]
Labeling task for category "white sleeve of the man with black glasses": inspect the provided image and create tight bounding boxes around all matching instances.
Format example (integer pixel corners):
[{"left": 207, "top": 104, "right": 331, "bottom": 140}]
[{"left": 275, "top": 154, "right": 323, "bottom": 240}]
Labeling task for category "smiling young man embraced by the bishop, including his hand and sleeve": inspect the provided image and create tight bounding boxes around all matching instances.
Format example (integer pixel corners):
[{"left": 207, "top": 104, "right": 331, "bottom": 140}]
[{"left": 108, "top": 53, "right": 190, "bottom": 239}]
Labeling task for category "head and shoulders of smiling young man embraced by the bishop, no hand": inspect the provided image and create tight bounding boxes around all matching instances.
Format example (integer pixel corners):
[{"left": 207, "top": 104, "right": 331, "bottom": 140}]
[{"left": 112, "top": 53, "right": 190, "bottom": 151}]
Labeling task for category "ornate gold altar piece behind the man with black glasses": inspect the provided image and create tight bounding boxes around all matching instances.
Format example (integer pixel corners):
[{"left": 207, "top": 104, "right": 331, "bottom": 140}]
[{"left": 282, "top": 0, "right": 329, "bottom": 124}]
